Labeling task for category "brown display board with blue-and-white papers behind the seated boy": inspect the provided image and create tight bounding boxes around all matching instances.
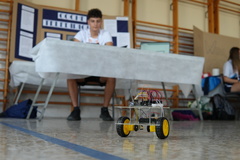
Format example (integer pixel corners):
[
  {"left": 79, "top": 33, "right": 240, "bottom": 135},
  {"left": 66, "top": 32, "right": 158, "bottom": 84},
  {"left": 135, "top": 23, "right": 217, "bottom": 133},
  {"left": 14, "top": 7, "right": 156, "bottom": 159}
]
[{"left": 10, "top": 0, "right": 133, "bottom": 62}]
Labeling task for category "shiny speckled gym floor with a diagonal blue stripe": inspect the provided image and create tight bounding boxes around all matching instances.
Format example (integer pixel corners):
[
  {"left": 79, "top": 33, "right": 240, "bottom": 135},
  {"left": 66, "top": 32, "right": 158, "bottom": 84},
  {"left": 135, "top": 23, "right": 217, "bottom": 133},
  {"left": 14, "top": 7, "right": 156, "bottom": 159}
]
[{"left": 0, "top": 118, "right": 240, "bottom": 160}]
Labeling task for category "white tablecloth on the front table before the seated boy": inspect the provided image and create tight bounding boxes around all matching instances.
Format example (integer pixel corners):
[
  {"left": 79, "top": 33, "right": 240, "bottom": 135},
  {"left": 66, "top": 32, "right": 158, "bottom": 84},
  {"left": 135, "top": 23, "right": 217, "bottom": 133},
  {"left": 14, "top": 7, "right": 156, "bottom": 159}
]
[{"left": 31, "top": 39, "right": 204, "bottom": 97}]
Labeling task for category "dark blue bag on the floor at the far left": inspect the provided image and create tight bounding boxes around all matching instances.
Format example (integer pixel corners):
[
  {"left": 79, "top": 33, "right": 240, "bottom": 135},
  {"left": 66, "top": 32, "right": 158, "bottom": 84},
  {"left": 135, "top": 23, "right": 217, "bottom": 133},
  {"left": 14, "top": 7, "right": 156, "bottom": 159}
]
[{"left": 0, "top": 99, "right": 37, "bottom": 118}]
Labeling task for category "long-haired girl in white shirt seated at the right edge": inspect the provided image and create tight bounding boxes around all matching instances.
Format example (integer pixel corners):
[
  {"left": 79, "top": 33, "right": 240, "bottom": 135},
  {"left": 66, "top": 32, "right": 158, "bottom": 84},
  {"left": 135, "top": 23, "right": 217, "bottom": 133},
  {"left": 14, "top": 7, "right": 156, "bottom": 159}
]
[{"left": 223, "top": 47, "right": 240, "bottom": 92}]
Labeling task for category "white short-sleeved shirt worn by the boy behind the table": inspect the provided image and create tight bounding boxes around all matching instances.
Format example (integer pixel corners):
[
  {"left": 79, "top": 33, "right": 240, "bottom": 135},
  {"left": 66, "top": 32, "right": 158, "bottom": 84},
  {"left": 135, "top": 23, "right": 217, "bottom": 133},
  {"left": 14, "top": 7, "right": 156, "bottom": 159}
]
[{"left": 74, "top": 29, "right": 112, "bottom": 45}]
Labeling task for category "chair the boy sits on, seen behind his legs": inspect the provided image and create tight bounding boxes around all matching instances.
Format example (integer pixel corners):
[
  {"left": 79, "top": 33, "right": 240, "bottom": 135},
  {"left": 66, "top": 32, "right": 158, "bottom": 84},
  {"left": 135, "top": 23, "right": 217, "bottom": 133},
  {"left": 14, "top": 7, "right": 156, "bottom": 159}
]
[{"left": 77, "top": 77, "right": 116, "bottom": 118}]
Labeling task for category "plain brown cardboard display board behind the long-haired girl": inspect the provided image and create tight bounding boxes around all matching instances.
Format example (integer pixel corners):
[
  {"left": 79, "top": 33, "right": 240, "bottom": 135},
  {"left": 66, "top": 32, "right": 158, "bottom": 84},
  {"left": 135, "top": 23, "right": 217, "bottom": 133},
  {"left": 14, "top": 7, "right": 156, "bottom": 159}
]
[{"left": 194, "top": 27, "right": 240, "bottom": 73}]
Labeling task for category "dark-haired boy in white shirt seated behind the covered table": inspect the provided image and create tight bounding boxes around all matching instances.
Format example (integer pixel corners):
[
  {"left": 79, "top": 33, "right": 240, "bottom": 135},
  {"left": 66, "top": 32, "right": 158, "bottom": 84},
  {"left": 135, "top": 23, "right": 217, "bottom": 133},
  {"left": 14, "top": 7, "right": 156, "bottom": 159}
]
[{"left": 67, "top": 9, "right": 116, "bottom": 121}]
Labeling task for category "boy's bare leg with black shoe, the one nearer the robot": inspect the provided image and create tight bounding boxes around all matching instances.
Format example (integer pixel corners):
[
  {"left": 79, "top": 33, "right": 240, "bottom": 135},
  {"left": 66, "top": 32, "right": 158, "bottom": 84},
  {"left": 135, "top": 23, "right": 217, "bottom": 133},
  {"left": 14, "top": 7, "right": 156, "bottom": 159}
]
[{"left": 100, "top": 77, "right": 116, "bottom": 121}]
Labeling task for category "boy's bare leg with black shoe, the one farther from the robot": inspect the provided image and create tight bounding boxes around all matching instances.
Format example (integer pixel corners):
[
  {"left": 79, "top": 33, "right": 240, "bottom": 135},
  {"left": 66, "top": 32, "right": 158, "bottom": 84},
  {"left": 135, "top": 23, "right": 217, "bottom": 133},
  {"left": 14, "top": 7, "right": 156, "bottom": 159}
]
[{"left": 67, "top": 79, "right": 84, "bottom": 121}]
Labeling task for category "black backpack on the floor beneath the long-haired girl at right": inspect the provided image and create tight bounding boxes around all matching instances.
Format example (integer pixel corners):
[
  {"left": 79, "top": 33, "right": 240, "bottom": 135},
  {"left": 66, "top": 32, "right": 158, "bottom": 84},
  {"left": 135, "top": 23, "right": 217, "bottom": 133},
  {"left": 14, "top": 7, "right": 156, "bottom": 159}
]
[{"left": 212, "top": 94, "right": 235, "bottom": 120}]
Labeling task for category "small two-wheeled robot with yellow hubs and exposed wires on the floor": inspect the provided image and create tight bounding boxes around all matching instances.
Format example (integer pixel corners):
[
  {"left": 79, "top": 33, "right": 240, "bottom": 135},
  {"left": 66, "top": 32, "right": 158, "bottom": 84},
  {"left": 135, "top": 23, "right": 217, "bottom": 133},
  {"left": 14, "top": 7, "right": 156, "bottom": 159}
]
[{"left": 116, "top": 90, "right": 170, "bottom": 139}]
